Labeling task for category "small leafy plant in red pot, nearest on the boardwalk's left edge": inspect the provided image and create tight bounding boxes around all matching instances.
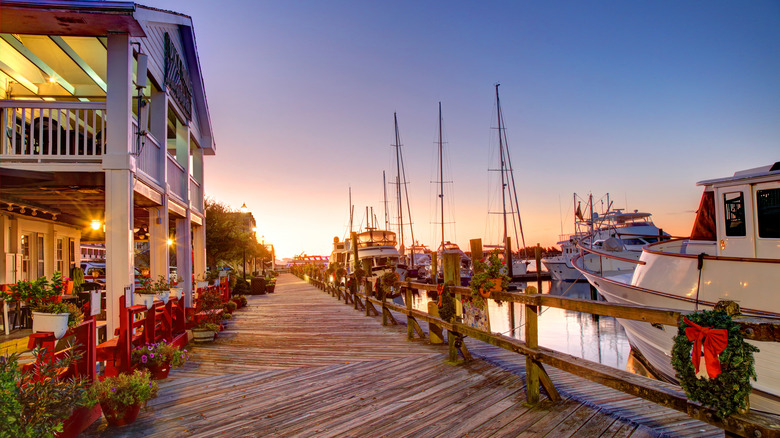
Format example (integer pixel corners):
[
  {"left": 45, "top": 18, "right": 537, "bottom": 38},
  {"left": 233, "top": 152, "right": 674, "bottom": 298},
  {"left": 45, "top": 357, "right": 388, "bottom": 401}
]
[{"left": 90, "top": 370, "right": 157, "bottom": 426}]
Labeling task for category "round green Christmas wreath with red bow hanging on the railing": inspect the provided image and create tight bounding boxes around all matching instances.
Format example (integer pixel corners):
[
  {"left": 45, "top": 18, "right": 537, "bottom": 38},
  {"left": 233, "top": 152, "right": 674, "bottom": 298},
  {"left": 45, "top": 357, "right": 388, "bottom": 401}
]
[{"left": 672, "top": 310, "right": 758, "bottom": 418}]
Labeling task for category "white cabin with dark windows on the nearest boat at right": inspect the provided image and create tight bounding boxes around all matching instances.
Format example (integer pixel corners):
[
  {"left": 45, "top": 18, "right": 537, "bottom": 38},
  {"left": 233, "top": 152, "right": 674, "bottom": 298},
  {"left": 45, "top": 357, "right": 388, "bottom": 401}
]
[{"left": 686, "top": 162, "right": 780, "bottom": 259}]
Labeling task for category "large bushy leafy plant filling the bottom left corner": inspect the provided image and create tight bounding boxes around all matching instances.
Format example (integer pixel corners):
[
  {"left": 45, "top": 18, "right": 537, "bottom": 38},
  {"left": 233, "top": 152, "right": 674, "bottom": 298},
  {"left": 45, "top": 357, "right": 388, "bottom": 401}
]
[{"left": 0, "top": 348, "right": 94, "bottom": 437}]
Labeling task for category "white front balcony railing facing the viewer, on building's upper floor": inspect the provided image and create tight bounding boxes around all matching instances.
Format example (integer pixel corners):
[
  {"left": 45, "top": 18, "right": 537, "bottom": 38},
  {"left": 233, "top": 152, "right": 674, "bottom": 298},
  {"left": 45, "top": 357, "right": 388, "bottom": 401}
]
[{"left": 0, "top": 100, "right": 106, "bottom": 161}]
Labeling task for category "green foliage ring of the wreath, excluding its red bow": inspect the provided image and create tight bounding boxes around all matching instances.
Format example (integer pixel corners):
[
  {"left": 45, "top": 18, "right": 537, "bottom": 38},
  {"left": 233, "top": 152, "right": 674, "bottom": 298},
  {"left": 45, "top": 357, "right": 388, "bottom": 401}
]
[{"left": 672, "top": 310, "right": 758, "bottom": 418}]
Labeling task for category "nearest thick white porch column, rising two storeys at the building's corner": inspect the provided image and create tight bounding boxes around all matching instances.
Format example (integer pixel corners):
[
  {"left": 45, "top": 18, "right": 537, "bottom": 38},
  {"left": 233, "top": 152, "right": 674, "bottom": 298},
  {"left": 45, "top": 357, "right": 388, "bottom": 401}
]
[{"left": 103, "top": 33, "right": 135, "bottom": 336}]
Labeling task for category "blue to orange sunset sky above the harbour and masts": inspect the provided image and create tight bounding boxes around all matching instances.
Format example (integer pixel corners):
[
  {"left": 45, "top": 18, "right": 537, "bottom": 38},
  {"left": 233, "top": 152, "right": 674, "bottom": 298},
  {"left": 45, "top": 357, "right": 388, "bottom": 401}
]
[{"left": 140, "top": 0, "right": 780, "bottom": 257}]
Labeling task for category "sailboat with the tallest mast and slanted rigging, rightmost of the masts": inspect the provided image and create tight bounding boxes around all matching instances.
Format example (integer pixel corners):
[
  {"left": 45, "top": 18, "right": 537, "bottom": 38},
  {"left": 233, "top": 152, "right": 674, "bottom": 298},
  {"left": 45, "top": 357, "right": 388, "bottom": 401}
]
[{"left": 485, "top": 84, "right": 528, "bottom": 278}]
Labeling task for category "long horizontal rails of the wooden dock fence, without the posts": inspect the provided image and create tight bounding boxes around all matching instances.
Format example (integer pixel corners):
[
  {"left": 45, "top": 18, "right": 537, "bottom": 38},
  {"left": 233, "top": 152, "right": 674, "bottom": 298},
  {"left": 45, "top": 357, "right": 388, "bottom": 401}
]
[{"left": 309, "top": 279, "right": 780, "bottom": 436}]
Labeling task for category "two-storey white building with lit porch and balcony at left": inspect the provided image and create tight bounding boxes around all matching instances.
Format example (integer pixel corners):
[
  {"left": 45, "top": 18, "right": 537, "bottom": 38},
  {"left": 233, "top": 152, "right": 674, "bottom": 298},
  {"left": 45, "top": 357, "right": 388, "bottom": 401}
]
[{"left": 0, "top": 0, "right": 216, "bottom": 333}]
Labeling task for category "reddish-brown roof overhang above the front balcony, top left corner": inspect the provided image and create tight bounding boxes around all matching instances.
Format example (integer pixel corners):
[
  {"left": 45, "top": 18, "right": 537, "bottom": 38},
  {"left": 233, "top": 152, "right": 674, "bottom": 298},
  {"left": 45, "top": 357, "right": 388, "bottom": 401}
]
[{"left": 0, "top": 0, "right": 146, "bottom": 37}]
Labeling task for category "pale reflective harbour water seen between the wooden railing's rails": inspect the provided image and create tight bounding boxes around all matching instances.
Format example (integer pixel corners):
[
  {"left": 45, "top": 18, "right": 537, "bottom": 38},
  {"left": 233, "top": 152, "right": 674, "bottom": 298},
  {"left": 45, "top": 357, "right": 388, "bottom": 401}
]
[{"left": 412, "top": 281, "right": 631, "bottom": 370}]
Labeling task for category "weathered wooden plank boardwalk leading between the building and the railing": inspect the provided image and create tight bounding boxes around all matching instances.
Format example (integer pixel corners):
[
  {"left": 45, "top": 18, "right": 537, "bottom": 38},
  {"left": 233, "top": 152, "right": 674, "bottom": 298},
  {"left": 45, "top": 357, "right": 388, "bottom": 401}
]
[{"left": 84, "top": 274, "right": 723, "bottom": 437}]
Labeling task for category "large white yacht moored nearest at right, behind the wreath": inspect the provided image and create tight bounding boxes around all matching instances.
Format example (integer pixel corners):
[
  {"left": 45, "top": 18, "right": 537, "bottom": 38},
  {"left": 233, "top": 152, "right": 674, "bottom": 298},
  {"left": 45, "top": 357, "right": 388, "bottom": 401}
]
[{"left": 574, "top": 162, "right": 780, "bottom": 414}]
